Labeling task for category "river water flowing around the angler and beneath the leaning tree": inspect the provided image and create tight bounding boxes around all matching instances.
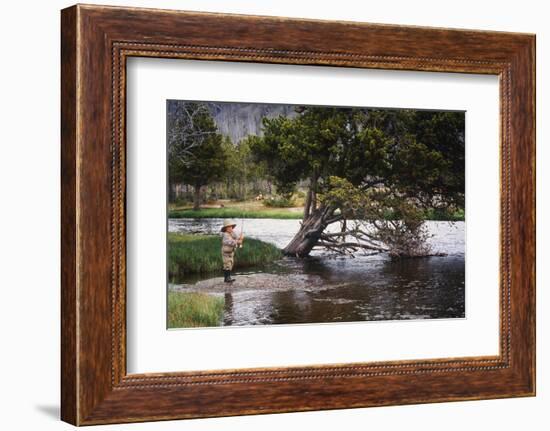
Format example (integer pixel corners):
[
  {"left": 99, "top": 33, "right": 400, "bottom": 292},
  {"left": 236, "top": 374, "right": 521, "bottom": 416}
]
[{"left": 168, "top": 219, "right": 465, "bottom": 326}]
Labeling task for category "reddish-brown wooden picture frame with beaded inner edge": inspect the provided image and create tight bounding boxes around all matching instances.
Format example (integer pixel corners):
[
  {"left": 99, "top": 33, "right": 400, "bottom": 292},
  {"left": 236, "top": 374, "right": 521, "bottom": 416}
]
[{"left": 61, "top": 5, "right": 535, "bottom": 425}]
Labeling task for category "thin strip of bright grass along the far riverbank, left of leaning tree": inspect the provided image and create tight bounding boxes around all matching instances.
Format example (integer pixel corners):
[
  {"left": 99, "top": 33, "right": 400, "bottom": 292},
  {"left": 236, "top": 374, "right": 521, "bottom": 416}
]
[{"left": 168, "top": 208, "right": 303, "bottom": 219}]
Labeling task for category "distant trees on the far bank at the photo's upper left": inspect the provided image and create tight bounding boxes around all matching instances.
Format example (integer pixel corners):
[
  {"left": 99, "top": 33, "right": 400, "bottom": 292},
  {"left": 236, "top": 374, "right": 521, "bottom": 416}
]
[{"left": 167, "top": 101, "right": 273, "bottom": 209}]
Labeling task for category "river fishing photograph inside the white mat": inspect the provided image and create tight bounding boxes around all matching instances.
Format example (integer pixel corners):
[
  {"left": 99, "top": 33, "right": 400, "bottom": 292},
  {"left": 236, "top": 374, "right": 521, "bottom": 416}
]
[{"left": 166, "top": 100, "right": 466, "bottom": 329}]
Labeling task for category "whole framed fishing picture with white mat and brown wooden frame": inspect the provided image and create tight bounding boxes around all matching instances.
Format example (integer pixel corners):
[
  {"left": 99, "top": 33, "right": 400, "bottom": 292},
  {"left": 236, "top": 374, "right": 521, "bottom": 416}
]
[{"left": 61, "top": 5, "right": 535, "bottom": 425}]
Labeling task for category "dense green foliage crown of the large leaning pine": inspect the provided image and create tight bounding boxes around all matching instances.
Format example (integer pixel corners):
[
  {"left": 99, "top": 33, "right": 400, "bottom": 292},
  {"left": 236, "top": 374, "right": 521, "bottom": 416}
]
[{"left": 251, "top": 106, "right": 464, "bottom": 207}]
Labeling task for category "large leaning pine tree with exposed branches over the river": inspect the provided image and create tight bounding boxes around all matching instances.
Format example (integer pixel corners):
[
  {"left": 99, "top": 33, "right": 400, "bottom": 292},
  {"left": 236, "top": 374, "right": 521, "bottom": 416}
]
[{"left": 252, "top": 107, "right": 464, "bottom": 257}]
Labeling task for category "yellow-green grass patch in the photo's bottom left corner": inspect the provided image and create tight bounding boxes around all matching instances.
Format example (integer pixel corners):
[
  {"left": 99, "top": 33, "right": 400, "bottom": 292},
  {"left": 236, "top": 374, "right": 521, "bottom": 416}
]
[{"left": 168, "top": 292, "right": 225, "bottom": 328}]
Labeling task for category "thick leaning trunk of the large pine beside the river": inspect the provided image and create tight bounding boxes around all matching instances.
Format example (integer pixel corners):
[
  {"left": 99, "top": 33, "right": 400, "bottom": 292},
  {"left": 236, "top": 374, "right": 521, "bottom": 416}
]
[{"left": 283, "top": 206, "right": 334, "bottom": 257}]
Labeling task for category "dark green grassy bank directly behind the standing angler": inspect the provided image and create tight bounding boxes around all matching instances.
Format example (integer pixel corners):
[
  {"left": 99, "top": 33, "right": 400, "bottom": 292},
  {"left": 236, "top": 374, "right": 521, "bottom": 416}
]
[{"left": 168, "top": 233, "right": 281, "bottom": 280}]
